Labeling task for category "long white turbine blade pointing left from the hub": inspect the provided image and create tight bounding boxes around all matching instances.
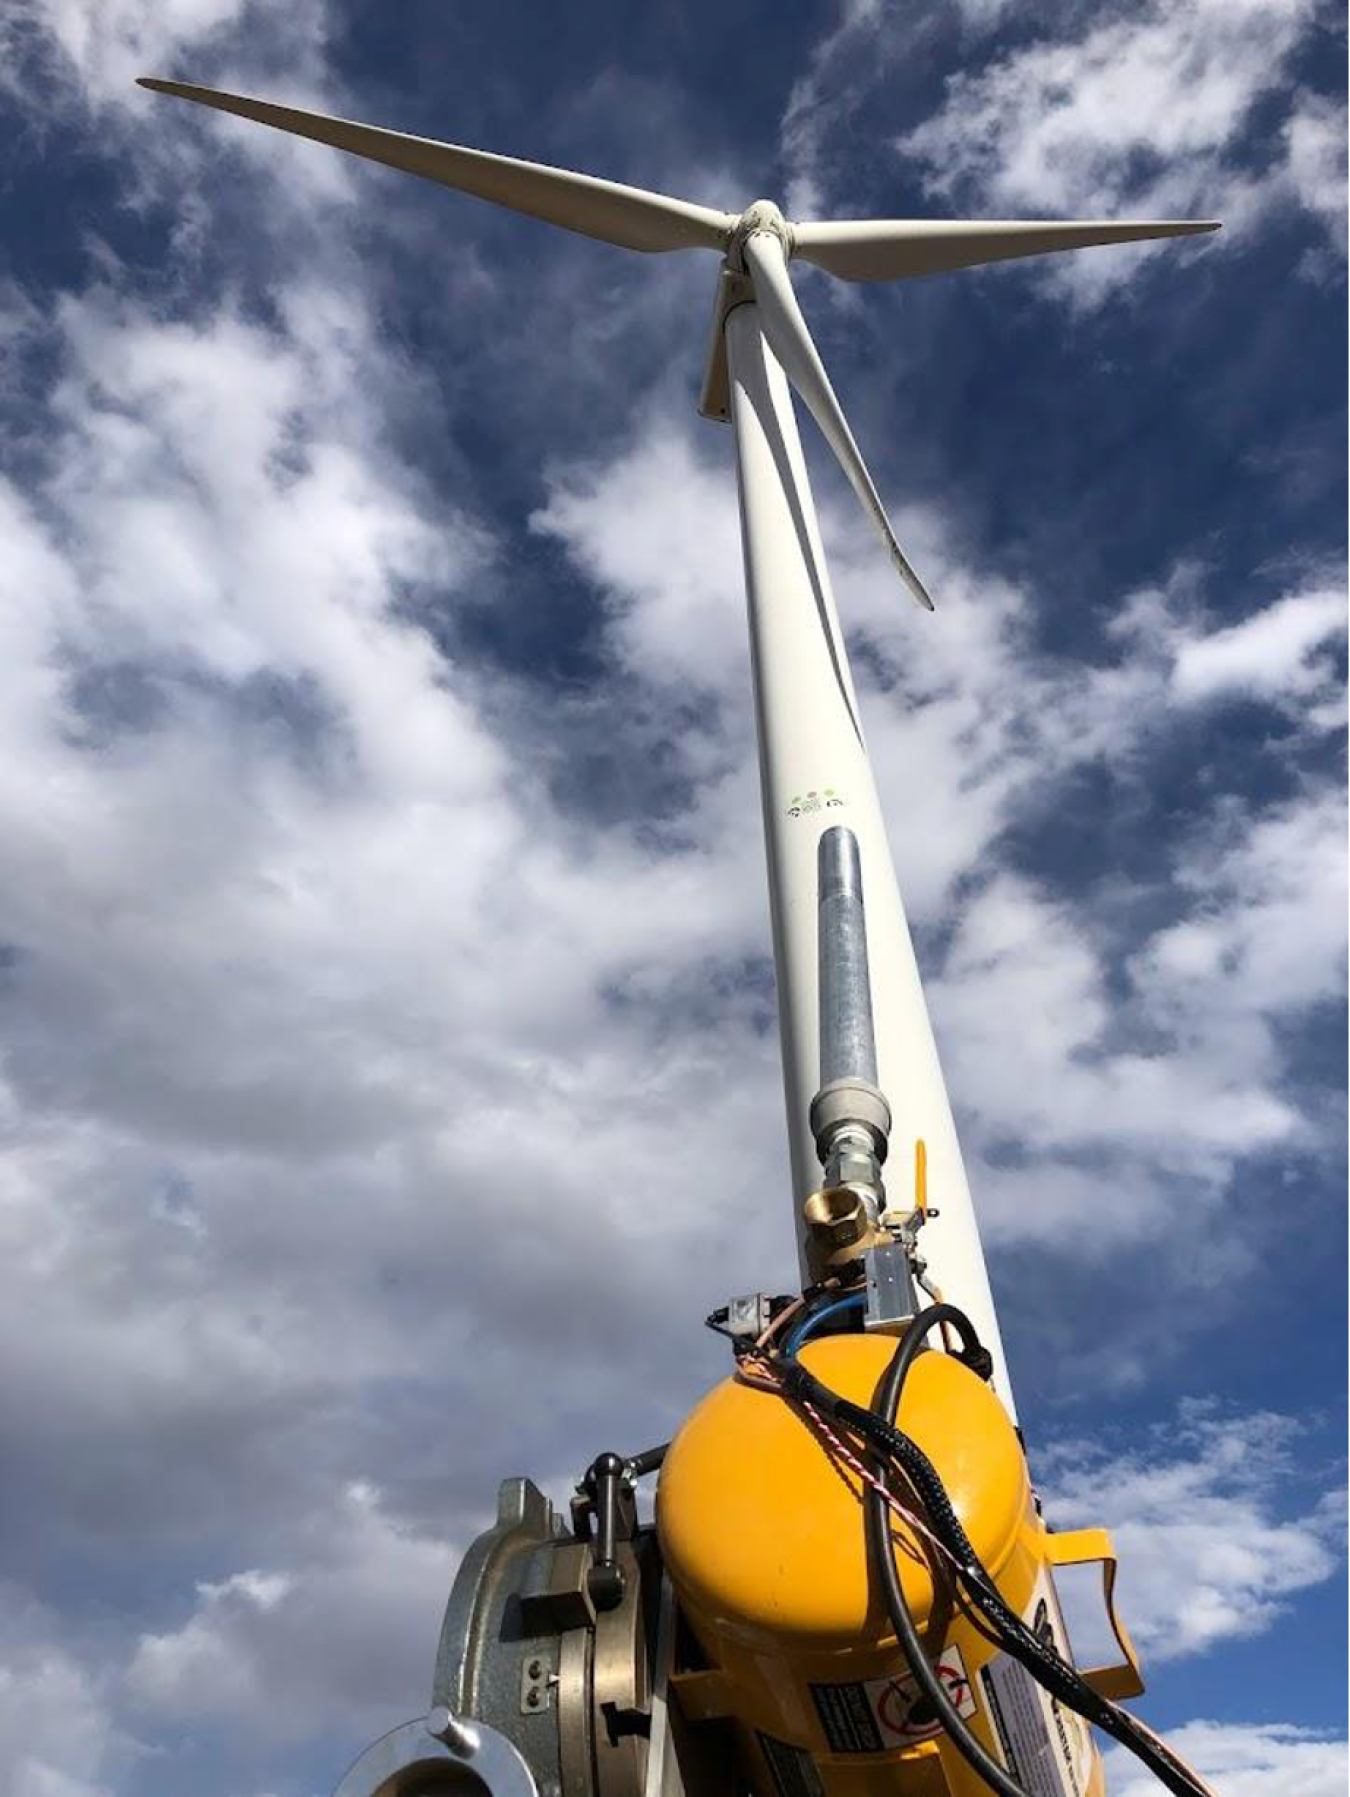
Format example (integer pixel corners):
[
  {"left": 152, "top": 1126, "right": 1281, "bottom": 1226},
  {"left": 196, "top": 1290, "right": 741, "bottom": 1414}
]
[{"left": 138, "top": 75, "right": 735, "bottom": 252}]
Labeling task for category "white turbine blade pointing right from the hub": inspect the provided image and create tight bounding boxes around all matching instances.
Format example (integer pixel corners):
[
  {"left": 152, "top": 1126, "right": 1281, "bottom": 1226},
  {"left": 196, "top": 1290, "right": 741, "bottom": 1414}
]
[{"left": 793, "top": 219, "right": 1219, "bottom": 280}]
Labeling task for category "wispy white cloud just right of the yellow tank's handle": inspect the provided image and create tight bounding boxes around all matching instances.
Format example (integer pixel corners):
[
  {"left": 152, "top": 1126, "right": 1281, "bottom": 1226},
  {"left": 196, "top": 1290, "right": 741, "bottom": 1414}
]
[{"left": 1037, "top": 1402, "right": 1345, "bottom": 1666}]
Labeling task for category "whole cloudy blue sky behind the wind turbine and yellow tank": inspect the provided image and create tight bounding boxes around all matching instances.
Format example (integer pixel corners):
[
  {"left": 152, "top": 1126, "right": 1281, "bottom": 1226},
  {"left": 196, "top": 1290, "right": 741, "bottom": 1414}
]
[{"left": 0, "top": 0, "right": 1346, "bottom": 1797}]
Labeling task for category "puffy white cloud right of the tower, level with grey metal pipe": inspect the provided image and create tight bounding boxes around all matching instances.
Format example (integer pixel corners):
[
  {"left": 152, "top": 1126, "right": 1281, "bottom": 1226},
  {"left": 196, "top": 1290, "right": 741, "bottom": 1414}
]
[{"left": 931, "top": 772, "right": 1346, "bottom": 1249}]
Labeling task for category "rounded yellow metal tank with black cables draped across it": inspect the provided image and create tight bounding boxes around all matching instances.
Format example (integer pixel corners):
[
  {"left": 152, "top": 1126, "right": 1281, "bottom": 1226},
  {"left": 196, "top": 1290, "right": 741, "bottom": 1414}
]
[{"left": 656, "top": 1335, "right": 1102, "bottom": 1797}]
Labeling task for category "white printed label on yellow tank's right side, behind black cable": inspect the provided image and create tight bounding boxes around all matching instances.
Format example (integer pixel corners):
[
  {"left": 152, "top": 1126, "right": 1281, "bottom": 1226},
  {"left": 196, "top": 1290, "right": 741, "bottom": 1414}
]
[{"left": 980, "top": 1574, "right": 1093, "bottom": 1797}]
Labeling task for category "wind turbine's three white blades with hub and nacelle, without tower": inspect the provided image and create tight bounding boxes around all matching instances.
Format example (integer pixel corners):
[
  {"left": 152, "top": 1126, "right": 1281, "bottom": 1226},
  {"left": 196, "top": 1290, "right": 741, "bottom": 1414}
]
[{"left": 140, "top": 77, "right": 1219, "bottom": 611}]
